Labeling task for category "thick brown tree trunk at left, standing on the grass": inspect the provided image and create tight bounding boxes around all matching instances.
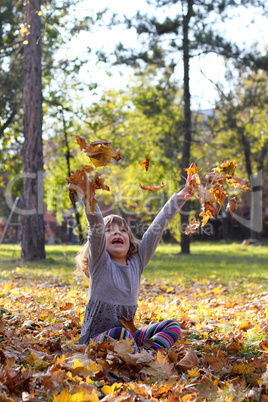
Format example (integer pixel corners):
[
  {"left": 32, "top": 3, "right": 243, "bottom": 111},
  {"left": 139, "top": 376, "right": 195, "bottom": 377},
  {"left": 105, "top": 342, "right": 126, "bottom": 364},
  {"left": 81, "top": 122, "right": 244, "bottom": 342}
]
[{"left": 21, "top": 0, "right": 46, "bottom": 260}]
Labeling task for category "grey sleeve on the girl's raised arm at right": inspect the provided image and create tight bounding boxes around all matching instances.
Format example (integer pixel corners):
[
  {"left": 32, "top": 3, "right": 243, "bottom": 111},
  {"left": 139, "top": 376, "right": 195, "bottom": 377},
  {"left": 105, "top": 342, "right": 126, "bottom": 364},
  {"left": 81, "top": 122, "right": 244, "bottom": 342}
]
[{"left": 139, "top": 193, "right": 185, "bottom": 269}]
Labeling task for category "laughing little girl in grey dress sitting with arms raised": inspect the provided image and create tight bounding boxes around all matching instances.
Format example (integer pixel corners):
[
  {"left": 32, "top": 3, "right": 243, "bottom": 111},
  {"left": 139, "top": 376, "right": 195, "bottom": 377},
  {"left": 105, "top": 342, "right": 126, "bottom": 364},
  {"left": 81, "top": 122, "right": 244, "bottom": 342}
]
[{"left": 71, "top": 177, "right": 194, "bottom": 350}]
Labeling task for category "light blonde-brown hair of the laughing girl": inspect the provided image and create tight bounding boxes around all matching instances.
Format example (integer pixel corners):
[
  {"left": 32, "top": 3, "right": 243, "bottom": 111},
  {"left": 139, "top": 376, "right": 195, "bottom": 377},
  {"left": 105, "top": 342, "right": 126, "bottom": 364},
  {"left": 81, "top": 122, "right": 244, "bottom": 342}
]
[{"left": 75, "top": 215, "right": 140, "bottom": 278}]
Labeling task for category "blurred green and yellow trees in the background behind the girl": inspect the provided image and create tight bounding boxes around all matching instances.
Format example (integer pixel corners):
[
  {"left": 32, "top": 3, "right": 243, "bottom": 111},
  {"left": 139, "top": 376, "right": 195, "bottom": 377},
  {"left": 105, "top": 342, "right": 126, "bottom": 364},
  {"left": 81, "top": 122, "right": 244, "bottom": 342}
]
[{"left": 0, "top": 0, "right": 268, "bottom": 259}]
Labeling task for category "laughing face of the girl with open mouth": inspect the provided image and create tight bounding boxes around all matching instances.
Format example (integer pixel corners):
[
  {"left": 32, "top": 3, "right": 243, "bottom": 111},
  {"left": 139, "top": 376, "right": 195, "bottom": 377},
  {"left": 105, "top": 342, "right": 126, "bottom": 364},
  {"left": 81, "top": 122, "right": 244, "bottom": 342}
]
[{"left": 105, "top": 223, "right": 130, "bottom": 265}]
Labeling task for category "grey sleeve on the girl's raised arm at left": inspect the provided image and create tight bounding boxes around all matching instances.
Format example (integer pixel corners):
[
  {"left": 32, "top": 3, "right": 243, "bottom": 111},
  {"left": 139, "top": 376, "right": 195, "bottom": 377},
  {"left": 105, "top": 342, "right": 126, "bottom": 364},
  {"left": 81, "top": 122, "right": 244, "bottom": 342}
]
[{"left": 84, "top": 204, "right": 106, "bottom": 274}]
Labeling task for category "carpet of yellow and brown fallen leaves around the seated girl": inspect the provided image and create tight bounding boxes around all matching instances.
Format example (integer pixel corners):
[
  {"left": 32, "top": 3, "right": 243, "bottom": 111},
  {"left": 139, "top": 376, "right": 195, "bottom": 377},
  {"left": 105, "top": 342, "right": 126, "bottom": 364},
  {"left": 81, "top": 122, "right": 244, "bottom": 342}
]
[{"left": 0, "top": 268, "right": 268, "bottom": 402}]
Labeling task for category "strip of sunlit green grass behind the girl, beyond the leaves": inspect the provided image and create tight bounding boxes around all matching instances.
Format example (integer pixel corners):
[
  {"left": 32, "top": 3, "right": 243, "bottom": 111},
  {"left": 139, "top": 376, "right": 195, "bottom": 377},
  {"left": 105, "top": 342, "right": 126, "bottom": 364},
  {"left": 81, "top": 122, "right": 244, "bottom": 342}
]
[{"left": 0, "top": 242, "right": 268, "bottom": 286}]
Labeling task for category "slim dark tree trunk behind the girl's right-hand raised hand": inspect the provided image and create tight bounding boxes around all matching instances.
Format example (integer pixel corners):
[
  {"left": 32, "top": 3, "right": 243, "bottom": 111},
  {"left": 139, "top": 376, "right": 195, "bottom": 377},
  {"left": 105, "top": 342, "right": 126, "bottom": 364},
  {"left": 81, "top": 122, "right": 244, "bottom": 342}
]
[{"left": 180, "top": 0, "right": 193, "bottom": 254}]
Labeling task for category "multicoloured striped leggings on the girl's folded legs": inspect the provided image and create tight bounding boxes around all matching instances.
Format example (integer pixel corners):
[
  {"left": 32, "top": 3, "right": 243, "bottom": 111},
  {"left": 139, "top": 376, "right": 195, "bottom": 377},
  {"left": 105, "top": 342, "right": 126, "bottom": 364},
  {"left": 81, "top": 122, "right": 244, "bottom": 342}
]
[{"left": 94, "top": 320, "right": 181, "bottom": 351}]
